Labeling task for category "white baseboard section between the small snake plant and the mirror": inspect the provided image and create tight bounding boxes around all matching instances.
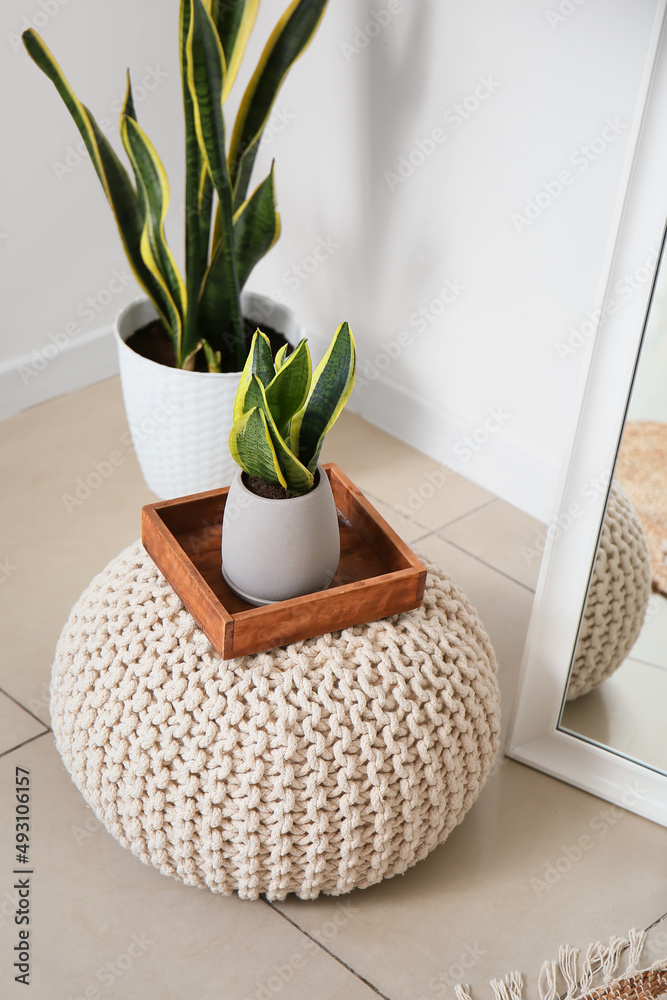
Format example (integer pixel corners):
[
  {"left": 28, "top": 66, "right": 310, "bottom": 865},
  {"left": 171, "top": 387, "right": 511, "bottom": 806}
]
[{"left": 350, "top": 373, "right": 560, "bottom": 523}]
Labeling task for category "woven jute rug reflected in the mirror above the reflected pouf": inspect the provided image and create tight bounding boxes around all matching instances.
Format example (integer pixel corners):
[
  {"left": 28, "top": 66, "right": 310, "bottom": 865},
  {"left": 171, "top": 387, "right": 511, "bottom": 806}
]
[{"left": 616, "top": 420, "right": 667, "bottom": 596}]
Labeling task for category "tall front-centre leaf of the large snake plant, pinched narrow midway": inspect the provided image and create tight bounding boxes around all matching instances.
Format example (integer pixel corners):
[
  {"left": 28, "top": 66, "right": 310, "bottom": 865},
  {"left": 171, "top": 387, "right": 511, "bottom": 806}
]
[{"left": 183, "top": 0, "right": 245, "bottom": 369}]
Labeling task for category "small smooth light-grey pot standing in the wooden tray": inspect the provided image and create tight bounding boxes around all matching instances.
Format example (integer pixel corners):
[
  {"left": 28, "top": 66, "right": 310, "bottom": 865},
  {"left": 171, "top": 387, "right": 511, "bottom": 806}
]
[{"left": 222, "top": 467, "right": 340, "bottom": 605}]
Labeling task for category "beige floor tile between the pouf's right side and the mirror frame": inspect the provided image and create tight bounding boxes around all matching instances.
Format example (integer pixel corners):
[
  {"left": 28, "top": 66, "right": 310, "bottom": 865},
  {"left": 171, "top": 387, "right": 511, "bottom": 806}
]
[{"left": 415, "top": 535, "right": 533, "bottom": 740}]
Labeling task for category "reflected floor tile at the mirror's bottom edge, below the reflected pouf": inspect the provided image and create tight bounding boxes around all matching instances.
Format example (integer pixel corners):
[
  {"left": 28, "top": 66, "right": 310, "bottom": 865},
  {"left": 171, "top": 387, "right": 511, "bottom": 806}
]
[{"left": 561, "top": 657, "right": 667, "bottom": 772}]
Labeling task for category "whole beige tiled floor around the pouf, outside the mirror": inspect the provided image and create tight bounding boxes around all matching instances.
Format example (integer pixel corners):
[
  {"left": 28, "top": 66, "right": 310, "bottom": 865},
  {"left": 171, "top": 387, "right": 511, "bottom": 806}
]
[{"left": 0, "top": 379, "right": 667, "bottom": 1000}]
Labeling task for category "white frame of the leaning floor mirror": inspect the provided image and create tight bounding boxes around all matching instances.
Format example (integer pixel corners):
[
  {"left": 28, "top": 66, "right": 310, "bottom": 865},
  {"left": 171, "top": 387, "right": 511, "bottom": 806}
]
[{"left": 505, "top": 0, "right": 667, "bottom": 826}]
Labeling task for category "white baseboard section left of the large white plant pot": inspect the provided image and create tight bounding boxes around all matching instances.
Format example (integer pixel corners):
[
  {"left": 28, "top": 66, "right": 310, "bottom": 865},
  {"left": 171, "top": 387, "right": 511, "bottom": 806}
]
[{"left": 0, "top": 326, "right": 118, "bottom": 419}]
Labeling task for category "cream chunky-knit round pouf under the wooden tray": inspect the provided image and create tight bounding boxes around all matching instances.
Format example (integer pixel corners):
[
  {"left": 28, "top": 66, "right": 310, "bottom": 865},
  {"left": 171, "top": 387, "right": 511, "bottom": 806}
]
[{"left": 51, "top": 542, "right": 499, "bottom": 899}]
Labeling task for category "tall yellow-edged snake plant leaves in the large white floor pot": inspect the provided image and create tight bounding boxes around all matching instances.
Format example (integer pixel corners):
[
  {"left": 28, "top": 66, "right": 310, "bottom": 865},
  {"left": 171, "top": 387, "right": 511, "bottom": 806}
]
[{"left": 23, "top": 0, "right": 327, "bottom": 371}]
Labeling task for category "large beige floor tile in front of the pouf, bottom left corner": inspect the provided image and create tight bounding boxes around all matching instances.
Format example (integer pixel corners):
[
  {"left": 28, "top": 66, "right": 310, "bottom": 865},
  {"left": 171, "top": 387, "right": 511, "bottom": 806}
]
[{"left": 0, "top": 734, "right": 384, "bottom": 1000}]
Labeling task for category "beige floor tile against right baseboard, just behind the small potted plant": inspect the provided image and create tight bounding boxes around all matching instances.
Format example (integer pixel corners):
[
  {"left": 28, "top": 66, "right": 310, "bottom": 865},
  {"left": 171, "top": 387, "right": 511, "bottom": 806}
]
[{"left": 323, "top": 413, "right": 493, "bottom": 530}]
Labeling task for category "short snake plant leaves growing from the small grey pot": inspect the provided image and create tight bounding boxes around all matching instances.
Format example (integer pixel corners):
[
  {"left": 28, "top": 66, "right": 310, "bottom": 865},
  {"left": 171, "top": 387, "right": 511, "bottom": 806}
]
[{"left": 229, "top": 323, "right": 356, "bottom": 496}]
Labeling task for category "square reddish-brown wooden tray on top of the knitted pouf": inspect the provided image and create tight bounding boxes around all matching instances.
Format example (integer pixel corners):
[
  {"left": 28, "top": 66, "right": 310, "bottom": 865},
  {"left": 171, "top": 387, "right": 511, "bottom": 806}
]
[{"left": 141, "top": 463, "right": 426, "bottom": 659}]
